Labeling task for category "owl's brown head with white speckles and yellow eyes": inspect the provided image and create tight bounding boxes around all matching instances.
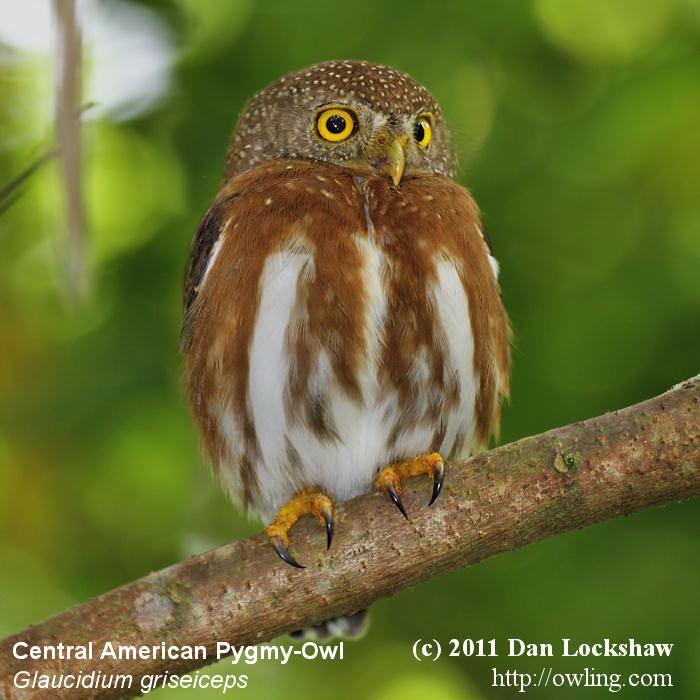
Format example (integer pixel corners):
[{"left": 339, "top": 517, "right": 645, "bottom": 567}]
[{"left": 227, "top": 61, "right": 455, "bottom": 185}]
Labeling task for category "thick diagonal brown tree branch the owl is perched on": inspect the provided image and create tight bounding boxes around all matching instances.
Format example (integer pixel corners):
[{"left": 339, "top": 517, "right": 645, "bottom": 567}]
[{"left": 0, "top": 375, "right": 700, "bottom": 700}]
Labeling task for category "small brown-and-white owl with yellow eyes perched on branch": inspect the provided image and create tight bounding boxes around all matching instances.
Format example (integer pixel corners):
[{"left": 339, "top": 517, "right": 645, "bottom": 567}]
[{"left": 182, "top": 61, "right": 509, "bottom": 636}]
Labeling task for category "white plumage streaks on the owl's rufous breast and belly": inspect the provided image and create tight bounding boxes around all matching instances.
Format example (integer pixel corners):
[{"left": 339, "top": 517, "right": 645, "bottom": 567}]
[{"left": 220, "top": 236, "right": 477, "bottom": 518}]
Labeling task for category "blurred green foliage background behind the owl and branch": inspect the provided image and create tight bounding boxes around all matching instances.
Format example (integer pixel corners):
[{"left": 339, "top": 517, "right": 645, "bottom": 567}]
[{"left": 0, "top": 0, "right": 700, "bottom": 700}]
